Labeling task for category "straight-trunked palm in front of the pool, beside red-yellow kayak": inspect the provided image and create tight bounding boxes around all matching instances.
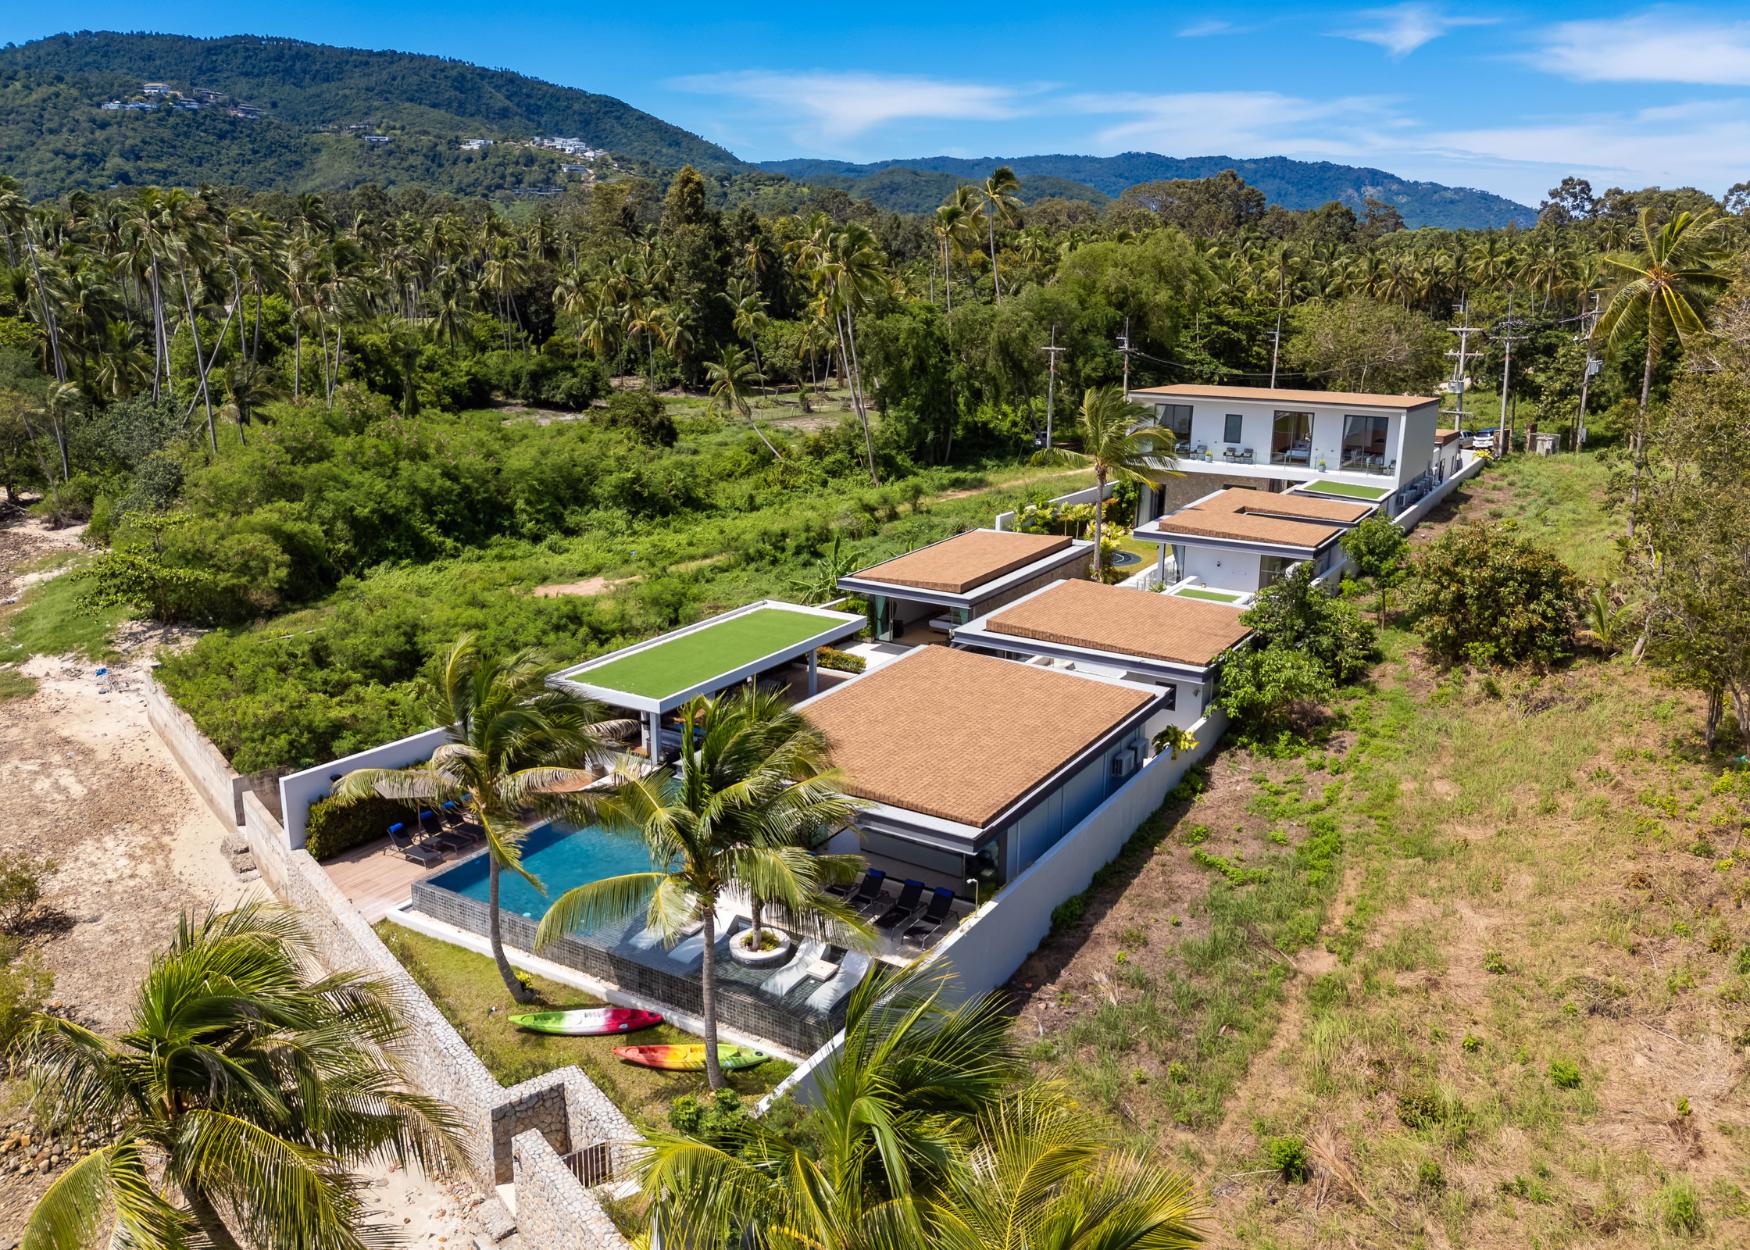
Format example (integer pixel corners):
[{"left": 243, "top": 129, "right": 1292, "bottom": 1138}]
[{"left": 536, "top": 692, "right": 868, "bottom": 1089}]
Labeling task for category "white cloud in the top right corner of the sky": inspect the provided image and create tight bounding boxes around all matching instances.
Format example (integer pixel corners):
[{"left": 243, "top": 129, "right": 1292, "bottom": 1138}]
[{"left": 1523, "top": 9, "right": 1750, "bottom": 86}]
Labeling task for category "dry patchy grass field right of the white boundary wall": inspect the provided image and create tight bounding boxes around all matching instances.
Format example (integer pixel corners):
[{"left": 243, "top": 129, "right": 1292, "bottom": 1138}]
[{"left": 1010, "top": 457, "right": 1750, "bottom": 1250}]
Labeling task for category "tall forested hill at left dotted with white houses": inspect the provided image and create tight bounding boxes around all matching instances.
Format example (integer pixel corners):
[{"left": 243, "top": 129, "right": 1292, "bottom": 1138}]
[{"left": 0, "top": 32, "right": 751, "bottom": 198}]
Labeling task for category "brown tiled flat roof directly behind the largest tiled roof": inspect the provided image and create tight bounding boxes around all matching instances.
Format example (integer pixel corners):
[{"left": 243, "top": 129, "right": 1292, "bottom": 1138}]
[{"left": 985, "top": 581, "right": 1251, "bottom": 664}]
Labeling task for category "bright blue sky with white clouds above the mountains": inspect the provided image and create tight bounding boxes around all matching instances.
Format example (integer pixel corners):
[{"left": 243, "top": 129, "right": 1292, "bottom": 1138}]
[{"left": 10, "top": 0, "right": 1750, "bottom": 203}]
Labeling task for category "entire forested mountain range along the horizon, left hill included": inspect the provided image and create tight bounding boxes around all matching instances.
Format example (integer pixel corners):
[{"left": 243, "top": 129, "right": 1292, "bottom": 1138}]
[{"left": 0, "top": 32, "right": 1537, "bottom": 229}]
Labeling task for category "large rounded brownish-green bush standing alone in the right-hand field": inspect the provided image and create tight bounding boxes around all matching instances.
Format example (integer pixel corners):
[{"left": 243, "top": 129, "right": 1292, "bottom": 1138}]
[{"left": 1407, "top": 522, "right": 1582, "bottom": 664}]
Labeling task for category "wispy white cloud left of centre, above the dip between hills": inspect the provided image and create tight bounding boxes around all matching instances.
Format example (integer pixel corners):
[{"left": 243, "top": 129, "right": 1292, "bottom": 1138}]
[{"left": 670, "top": 70, "right": 1026, "bottom": 142}]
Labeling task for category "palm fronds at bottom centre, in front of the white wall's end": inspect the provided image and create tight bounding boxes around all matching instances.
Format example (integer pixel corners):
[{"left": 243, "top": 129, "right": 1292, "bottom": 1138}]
[{"left": 641, "top": 965, "right": 1202, "bottom": 1250}]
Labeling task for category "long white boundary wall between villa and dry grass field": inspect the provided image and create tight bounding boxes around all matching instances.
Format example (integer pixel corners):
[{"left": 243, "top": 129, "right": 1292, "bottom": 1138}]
[{"left": 760, "top": 709, "right": 1227, "bottom": 1112}]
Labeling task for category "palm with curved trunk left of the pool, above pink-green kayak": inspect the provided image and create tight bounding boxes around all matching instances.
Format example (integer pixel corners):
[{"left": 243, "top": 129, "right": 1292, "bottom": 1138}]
[{"left": 333, "top": 634, "right": 627, "bottom": 1003}]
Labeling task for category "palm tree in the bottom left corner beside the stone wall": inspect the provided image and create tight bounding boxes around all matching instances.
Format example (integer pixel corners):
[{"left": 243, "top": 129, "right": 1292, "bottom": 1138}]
[{"left": 19, "top": 905, "right": 460, "bottom": 1250}]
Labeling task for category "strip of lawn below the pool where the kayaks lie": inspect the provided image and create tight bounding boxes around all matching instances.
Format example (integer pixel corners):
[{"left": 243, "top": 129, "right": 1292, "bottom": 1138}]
[{"left": 376, "top": 921, "right": 793, "bottom": 1127}]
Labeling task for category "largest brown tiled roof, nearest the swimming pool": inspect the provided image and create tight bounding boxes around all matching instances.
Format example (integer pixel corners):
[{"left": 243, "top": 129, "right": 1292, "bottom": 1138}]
[{"left": 807, "top": 644, "right": 1152, "bottom": 828}]
